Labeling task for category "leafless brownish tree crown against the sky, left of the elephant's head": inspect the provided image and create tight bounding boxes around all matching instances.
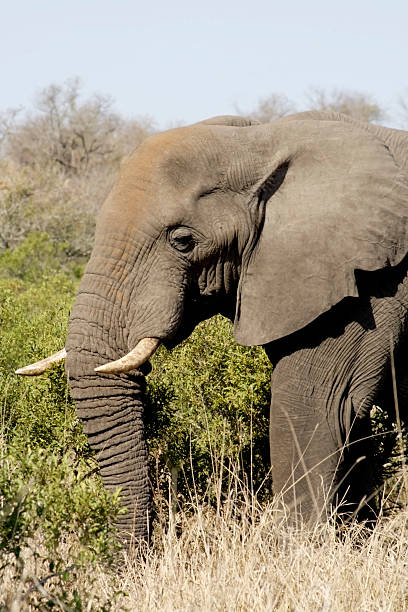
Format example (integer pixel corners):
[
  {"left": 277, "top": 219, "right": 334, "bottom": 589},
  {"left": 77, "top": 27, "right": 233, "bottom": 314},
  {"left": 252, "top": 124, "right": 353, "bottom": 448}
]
[{"left": 7, "top": 79, "right": 152, "bottom": 174}]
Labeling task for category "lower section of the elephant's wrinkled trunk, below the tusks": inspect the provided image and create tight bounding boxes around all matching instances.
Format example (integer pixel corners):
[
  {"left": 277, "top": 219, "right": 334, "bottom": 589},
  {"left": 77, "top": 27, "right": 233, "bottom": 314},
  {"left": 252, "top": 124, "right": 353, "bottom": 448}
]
[{"left": 67, "top": 353, "right": 151, "bottom": 540}]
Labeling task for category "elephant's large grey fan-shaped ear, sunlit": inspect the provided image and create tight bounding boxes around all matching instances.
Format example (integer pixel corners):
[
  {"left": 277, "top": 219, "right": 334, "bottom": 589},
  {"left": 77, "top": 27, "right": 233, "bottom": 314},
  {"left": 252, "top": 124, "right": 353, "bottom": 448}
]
[{"left": 234, "top": 120, "right": 408, "bottom": 345}]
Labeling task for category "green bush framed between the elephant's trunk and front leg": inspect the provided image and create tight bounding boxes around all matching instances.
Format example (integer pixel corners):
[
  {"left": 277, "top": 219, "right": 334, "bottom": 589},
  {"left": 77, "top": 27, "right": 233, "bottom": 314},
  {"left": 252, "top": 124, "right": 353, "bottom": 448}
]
[{"left": 146, "top": 316, "right": 271, "bottom": 506}]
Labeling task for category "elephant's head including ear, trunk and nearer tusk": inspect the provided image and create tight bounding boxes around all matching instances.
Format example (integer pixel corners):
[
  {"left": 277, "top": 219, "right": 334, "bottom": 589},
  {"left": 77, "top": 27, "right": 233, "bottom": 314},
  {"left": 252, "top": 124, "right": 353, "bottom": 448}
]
[{"left": 19, "top": 116, "right": 408, "bottom": 537}]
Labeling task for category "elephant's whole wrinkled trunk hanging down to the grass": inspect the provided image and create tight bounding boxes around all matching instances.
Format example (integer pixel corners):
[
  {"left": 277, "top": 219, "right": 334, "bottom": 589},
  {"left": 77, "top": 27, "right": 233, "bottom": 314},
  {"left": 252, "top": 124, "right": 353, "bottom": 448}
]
[{"left": 65, "top": 274, "right": 151, "bottom": 540}]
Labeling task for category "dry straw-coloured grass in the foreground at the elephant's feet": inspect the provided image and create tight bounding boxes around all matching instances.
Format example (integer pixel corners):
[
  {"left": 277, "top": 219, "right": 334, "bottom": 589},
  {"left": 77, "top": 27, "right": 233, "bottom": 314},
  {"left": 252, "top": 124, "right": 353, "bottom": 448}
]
[{"left": 3, "top": 486, "right": 408, "bottom": 612}]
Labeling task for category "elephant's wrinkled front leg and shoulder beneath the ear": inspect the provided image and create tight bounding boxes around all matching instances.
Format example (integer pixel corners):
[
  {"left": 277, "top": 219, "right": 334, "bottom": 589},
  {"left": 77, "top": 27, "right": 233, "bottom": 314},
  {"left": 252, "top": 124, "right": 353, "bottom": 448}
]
[{"left": 268, "top": 281, "right": 408, "bottom": 521}]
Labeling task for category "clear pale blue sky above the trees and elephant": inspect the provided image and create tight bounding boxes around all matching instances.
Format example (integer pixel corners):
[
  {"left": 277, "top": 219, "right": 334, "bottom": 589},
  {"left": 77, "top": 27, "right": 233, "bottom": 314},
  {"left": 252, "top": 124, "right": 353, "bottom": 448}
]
[{"left": 0, "top": 0, "right": 408, "bottom": 128}]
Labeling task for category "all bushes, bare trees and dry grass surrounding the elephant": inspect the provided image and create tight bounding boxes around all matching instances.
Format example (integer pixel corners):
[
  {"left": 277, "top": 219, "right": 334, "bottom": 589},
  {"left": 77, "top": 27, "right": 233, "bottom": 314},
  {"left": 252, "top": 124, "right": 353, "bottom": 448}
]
[{"left": 0, "top": 80, "right": 408, "bottom": 612}]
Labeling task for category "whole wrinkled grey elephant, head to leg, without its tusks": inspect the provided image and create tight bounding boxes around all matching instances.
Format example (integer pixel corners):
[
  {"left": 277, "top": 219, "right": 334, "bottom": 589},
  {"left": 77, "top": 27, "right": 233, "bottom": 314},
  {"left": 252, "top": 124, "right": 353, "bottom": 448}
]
[{"left": 66, "top": 112, "right": 408, "bottom": 538}]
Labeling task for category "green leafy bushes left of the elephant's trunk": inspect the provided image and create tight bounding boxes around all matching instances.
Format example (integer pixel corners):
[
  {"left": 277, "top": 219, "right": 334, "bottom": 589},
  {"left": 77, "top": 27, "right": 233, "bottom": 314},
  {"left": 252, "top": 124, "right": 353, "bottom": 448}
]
[{"left": 0, "top": 234, "right": 120, "bottom": 609}]
